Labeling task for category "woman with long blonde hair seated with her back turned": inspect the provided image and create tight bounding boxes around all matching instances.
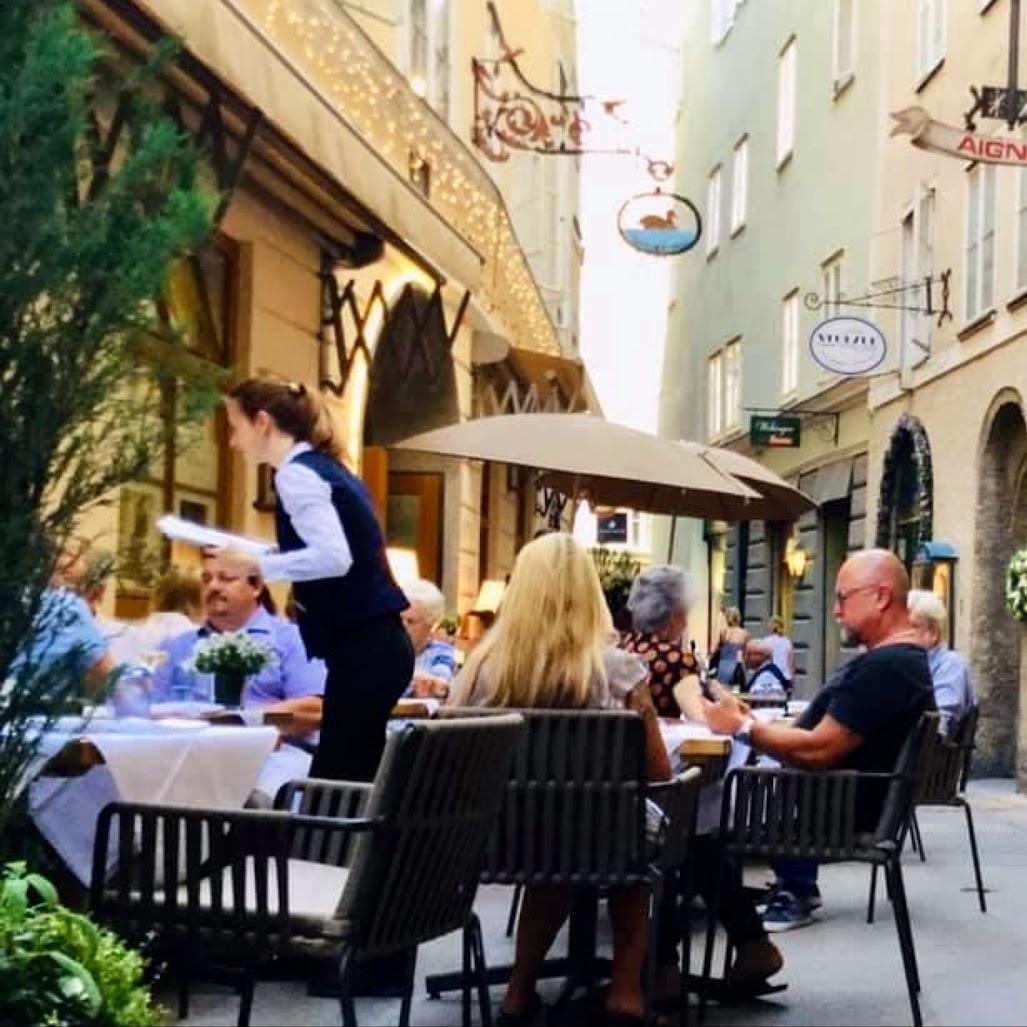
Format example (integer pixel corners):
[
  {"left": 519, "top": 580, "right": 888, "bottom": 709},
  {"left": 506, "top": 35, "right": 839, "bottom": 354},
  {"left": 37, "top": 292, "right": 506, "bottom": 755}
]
[{"left": 450, "top": 534, "right": 671, "bottom": 1024}]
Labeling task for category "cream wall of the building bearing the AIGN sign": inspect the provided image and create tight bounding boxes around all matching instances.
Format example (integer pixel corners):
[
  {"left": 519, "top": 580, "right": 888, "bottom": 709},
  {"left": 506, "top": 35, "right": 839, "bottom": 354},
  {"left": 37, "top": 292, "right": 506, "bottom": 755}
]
[{"left": 867, "top": 0, "right": 1027, "bottom": 652}]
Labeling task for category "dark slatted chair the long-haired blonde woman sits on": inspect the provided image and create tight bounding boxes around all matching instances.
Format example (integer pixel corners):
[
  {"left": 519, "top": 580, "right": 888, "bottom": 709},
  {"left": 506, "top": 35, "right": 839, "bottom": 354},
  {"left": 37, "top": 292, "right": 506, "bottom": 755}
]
[{"left": 425, "top": 709, "right": 699, "bottom": 1022}]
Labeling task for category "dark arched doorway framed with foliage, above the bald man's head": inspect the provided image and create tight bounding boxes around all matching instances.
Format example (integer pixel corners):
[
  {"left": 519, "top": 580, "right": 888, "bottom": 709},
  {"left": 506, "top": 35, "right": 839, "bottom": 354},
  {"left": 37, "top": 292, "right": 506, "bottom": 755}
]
[{"left": 876, "top": 414, "right": 935, "bottom": 567}]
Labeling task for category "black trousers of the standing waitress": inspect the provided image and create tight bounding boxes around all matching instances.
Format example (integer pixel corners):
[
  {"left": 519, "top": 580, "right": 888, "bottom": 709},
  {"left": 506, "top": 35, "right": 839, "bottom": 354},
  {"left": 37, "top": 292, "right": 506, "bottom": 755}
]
[{"left": 310, "top": 614, "right": 414, "bottom": 781}]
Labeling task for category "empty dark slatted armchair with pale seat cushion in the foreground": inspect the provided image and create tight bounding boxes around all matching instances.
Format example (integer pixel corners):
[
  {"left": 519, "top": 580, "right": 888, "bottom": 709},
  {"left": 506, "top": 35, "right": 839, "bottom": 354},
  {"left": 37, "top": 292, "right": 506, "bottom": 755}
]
[{"left": 90, "top": 714, "right": 524, "bottom": 1027}]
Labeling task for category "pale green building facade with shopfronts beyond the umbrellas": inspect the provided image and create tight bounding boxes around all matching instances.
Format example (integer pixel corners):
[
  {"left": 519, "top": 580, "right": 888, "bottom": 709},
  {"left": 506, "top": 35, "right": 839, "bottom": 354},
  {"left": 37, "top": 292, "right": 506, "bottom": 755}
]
[{"left": 655, "top": 0, "right": 882, "bottom": 693}]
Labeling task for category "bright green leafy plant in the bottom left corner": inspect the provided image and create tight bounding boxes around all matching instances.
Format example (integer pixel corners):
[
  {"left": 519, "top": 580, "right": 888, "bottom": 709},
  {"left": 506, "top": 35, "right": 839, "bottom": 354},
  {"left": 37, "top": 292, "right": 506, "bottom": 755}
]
[{"left": 0, "top": 863, "right": 162, "bottom": 1027}]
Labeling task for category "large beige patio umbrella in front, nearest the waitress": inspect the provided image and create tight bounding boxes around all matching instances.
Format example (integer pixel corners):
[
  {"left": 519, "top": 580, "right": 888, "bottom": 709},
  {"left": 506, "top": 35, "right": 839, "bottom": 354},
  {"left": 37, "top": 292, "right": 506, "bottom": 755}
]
[{"left": 395, "top": 414, "right": 799, "bottom": 521}]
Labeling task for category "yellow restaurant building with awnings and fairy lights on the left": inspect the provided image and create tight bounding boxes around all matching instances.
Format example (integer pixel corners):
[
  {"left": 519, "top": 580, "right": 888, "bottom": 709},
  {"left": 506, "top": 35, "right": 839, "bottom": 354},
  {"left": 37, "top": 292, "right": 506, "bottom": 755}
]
[{"left": 81, "top": 0, "right": 594, "bottom": 616}]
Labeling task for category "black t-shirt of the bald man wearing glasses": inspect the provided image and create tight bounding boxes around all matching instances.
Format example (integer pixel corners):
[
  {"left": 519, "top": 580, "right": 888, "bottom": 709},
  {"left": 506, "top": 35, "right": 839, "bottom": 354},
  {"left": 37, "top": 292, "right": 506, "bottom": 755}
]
[{"left": 798, "top": 643, "right": 935, "bottom": 831}]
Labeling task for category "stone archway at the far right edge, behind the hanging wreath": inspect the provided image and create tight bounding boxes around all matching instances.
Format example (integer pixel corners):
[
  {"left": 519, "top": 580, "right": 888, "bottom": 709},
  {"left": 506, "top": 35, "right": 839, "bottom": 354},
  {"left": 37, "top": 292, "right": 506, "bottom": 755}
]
[{"left": 971, "top": 390, "right": 1027, "bottom": 788}]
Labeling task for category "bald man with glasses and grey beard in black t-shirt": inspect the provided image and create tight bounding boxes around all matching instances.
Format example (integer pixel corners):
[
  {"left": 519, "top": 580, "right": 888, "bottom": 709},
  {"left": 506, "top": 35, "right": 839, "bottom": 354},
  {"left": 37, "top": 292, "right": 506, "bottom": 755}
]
[{"left": 707, "top": 549, "right": 935, "bottom": 931}]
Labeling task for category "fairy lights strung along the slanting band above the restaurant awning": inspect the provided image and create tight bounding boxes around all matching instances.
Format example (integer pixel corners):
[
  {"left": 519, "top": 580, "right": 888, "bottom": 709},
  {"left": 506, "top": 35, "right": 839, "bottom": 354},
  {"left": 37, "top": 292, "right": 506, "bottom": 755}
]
[{"left": 255, "top": 0, "right": 560, "bottom": 353}]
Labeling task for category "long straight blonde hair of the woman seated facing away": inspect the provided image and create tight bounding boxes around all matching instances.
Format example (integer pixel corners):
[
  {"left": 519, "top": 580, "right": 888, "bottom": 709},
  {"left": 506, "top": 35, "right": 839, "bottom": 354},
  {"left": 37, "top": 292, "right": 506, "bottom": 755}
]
[{"left": 461, "top": 533, "right": 613, "bottom": 709}]
